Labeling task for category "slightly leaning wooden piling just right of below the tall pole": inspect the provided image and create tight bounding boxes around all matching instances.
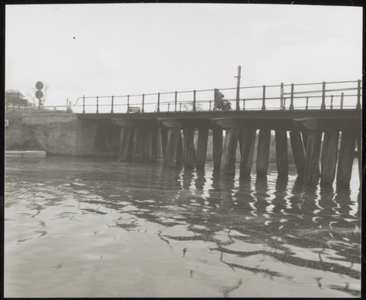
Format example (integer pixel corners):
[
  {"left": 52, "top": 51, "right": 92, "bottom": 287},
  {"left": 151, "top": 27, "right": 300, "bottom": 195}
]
[{"left": 239, "top": 128, "right": 257, "bottom": 177}]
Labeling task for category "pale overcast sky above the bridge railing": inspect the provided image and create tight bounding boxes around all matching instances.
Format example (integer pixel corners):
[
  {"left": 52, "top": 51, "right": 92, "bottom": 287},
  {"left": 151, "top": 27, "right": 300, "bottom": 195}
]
[{"left": 5, "top": 4, "right": 362, "bottom": 111}]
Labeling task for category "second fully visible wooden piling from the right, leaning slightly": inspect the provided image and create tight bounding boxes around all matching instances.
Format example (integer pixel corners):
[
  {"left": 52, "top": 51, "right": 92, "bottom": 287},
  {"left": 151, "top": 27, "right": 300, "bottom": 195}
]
[{"left": 320, "top": 131, "right": 339, "bottom": 186}]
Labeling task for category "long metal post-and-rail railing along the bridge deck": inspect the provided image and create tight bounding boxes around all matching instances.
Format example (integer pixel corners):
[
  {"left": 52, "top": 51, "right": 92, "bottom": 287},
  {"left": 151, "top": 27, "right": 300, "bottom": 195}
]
[{"left": 74, "top": 80, "right": 362, "bottom": 114}]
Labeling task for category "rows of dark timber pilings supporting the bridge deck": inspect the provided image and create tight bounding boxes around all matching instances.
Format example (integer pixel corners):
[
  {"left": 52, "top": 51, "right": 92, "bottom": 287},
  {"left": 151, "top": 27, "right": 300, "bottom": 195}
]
[{"left": 112, "top": 112, "right": 361, "bottom": 186}]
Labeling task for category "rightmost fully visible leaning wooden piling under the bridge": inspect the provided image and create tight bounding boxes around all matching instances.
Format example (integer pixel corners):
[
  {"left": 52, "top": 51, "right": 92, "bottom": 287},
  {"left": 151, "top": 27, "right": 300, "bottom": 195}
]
[{"left": 337, "top": 130, "right": 356, "bottom": 187}]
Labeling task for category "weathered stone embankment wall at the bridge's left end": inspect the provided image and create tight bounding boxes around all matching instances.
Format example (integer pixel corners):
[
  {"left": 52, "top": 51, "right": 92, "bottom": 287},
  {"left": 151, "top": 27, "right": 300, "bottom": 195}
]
[{"left": 5, "top": 111, "right": 118, "bottom": 156}]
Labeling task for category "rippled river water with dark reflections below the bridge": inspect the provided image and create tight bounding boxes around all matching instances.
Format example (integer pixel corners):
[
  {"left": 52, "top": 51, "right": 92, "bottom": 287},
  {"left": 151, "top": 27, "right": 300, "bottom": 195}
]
[{"left": 4, "top": 157, "right": 361, "bottom": 297}]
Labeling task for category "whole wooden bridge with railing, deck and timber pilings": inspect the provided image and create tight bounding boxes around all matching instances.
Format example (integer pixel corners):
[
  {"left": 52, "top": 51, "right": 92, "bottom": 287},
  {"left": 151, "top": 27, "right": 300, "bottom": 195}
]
[{"left": 75, "top": 80, "right": 362, "bottom": 186}]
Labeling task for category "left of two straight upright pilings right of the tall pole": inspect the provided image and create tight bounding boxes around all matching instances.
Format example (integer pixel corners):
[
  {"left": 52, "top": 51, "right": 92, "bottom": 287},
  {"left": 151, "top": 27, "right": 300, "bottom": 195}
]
[{"left": 257, "top": 128, "right": 271, "bottom": 177}]
